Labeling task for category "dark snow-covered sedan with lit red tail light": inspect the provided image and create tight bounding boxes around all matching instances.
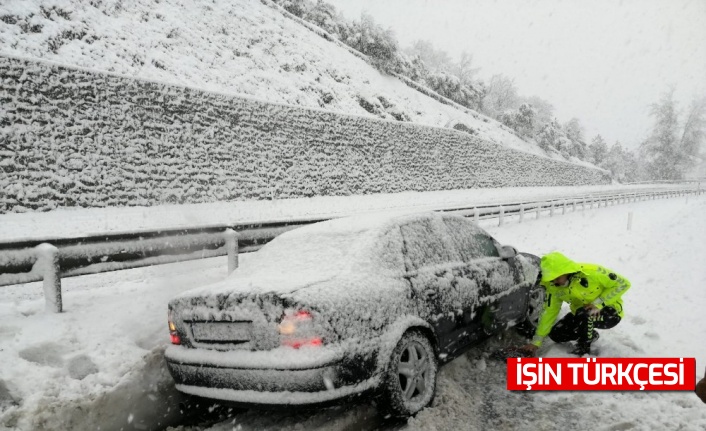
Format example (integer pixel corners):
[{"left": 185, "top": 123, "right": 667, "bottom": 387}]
[{"left": 165, "top": 213, "right": 542, "bottom": 416}]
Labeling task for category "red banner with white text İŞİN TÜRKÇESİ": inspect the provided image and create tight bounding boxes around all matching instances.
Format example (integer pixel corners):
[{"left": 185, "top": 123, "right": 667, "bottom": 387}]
[{"left": 507, "top": 358, "right": 696, "bottom": 391}]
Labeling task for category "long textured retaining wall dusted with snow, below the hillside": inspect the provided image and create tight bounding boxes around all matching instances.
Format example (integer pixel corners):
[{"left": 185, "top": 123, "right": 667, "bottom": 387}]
[{"left": 0, "top": 56, "right": 609, "bottom": 213}]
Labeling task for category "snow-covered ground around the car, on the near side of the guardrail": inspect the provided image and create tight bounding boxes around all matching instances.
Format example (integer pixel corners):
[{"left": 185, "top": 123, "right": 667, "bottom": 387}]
[{"left": 0, "top": 195, "right": 706, "bottom": 430}]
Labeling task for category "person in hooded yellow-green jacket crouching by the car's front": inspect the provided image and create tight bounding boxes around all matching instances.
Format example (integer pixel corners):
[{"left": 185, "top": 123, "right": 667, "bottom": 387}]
[{"left": 521, "top": 252, "right": 630, "bottom": 356}]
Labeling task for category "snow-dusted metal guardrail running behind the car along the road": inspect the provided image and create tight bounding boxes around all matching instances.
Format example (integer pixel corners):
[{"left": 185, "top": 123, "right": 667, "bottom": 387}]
[{"left": 0, "top": 187, "right": 702, "bottom": 312}]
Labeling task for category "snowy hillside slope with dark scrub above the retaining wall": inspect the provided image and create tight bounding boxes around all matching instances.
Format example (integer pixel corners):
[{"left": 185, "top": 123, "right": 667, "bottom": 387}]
[{"left": 0, "top": 0, "right": 545, "bottom": 155}]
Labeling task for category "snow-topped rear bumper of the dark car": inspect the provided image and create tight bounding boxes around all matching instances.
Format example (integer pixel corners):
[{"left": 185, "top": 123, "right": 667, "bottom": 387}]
[{"left": 165, "top": 346, "right": 378, "bottom": 405}]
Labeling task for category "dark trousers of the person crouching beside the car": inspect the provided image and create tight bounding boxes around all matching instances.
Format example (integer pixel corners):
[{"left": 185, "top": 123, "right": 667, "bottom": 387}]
[{"left": 549, "top": 307, "right": 620, "bottom": 346}]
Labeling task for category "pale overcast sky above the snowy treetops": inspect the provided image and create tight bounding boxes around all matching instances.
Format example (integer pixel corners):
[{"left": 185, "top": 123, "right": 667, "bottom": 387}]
[{"left": 327, "top": 0, "right": 706, "bottom": 148}]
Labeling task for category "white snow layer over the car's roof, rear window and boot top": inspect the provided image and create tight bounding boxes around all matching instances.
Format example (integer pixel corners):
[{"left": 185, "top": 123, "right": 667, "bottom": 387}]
[{"left": 175, "top": 212, "right": 484, "bottom": 296}]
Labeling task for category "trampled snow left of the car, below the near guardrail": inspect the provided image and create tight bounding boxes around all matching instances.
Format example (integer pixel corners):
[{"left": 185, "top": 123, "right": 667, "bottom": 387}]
[{"left": 0, "top": 258, "right": 226, "bottom": 430}]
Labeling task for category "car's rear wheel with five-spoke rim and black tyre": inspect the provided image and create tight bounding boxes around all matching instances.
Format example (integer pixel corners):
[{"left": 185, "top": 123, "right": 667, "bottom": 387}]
[{"left": 383, "top": 330, "right": 439, "bottom": 417}]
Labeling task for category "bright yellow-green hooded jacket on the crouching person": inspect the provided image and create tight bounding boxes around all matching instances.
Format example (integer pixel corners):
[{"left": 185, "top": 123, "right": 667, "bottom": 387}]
[{"left": 532, "top": 252, "right": 630, "bottom": 347}]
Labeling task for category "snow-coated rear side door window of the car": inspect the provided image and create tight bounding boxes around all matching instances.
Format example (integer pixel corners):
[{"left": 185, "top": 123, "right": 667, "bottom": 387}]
[{"left": 400, "top": 219, "right": 451, "bottom": 270}]
